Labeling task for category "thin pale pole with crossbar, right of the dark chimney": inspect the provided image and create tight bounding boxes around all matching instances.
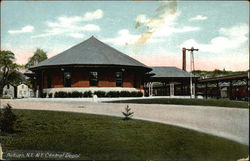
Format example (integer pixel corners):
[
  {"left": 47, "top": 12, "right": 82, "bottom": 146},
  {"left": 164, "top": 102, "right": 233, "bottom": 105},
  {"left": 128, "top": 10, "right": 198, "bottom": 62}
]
[{"left": 186, "top": 47, "right": 199, "bottom": 98}]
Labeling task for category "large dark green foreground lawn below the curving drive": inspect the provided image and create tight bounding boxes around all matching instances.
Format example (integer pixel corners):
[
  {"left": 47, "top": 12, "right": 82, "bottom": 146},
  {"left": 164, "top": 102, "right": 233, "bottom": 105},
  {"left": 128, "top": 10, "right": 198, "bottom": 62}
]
[{"left": 0, "top": 110, "right": 249, "bottom": 161}]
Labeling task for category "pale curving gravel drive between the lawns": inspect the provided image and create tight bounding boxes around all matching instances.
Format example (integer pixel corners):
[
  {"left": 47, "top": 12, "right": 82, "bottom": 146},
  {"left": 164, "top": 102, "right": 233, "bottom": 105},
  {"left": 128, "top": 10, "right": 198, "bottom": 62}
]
[{"left": 1, "top": 99, "right": 249, "bottom": 145}]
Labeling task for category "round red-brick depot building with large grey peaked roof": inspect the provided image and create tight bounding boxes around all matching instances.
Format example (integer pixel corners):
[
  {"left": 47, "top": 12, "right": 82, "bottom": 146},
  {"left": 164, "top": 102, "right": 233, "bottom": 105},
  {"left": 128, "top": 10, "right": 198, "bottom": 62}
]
[{"left": 29, "top": 36, "right": 152, "bottom": 96}]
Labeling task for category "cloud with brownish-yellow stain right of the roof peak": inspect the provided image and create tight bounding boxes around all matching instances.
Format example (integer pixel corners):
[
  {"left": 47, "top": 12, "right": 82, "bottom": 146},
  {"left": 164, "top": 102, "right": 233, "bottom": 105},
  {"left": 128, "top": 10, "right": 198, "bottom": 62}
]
[{"left": 134, "top": 2, "right": 200, "bottom": 49}]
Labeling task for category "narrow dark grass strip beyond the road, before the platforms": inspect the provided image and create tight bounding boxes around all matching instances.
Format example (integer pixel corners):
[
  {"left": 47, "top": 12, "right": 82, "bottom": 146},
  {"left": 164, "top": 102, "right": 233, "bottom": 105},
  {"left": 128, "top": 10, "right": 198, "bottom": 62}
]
[{"left": 109, "top": 98, "right": 249, "bottom": 108}]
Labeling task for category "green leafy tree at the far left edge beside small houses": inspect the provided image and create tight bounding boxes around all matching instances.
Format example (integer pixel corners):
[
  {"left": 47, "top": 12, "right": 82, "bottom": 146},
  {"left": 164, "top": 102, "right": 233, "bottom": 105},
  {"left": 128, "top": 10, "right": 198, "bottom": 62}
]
[{"left": 0, "top": 50, "right": 18, "bottom": 97}]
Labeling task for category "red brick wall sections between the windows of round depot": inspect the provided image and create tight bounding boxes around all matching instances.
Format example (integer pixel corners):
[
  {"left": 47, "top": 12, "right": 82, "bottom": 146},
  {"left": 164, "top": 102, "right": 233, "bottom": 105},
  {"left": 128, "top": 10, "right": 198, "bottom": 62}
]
[{"left": 43, "top": 66, "right": 146, "bottom": 89}]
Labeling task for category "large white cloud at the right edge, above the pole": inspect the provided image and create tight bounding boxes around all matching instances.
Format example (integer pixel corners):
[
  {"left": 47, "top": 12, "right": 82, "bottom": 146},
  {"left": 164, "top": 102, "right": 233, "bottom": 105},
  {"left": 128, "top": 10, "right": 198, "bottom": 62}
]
[{"left": 180, "top": 24, "right": 249, "bottom": 53}]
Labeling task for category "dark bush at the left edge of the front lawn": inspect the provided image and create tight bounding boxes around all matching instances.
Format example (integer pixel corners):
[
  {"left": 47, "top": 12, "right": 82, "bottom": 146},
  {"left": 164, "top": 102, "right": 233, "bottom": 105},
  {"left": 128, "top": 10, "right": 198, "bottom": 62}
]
[{"left": 0, "top": 104, "right": 19, "bottom": 133}]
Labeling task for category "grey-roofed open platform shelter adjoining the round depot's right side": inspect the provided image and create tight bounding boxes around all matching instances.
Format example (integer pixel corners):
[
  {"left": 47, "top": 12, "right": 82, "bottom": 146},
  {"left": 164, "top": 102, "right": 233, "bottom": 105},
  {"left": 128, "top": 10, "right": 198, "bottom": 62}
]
[{"left": 144, "top": 66, "right": 198, "bottom": 96}]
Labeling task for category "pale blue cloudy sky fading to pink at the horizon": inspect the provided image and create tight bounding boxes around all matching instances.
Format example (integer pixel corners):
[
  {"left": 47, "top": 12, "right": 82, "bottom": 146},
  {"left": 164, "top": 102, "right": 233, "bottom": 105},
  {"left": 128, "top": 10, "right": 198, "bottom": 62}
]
[{"left": 1, "top": 1, "right": 249, "bottom": 71}]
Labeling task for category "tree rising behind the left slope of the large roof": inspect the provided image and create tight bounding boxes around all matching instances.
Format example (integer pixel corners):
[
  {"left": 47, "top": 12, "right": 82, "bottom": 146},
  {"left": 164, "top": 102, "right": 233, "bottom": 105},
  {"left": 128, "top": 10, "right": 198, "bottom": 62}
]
[{"left": 25, "top": 48, "right": 48, "bottom": 68}]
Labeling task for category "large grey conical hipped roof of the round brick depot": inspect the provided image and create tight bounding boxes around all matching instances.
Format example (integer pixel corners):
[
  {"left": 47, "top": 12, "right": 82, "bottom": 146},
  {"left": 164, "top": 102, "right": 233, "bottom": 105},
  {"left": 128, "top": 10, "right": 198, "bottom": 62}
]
[{"left": 30, "top": 36, "right": 151, "bottom": 71}]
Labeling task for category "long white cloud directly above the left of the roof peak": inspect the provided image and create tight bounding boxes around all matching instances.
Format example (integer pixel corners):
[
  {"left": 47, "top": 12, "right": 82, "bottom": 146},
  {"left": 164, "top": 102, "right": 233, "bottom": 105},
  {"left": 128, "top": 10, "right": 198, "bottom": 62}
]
[{"left": 32, "top": 9, "right": 103, "bottom": 38}]
